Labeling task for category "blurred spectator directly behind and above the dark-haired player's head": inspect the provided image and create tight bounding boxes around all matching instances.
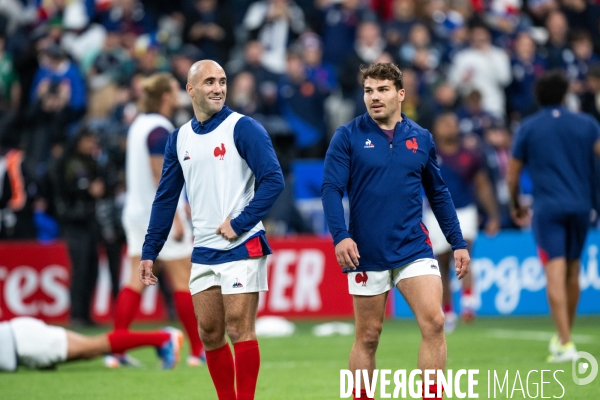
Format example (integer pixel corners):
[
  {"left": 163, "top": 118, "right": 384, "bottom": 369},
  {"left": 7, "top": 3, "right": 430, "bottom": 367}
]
[{"left": 339, "top": 22, "right": 386, "bottom": 99}]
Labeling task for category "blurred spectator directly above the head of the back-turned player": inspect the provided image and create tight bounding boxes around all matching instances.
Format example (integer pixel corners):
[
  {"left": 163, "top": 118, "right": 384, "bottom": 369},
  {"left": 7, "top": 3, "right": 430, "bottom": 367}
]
[{"left": 541, "top": 11, "right": 573, "bottom": 70}]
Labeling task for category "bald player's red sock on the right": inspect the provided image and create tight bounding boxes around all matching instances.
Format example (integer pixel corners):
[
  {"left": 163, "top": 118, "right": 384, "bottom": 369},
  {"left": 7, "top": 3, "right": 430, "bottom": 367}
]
[{"left": 233, "top": 340, "right": 260, "bottom": 400}]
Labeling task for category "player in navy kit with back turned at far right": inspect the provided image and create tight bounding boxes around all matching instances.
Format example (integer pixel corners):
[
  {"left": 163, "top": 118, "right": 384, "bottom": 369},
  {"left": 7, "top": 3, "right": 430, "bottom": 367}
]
[{"left": 507, "top": 71, "right": 600, "bottom": 362}]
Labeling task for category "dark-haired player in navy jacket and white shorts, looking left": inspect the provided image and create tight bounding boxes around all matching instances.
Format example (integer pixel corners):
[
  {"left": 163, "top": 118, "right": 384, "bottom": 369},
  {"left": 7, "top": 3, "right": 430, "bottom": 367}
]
[{"left": 322, "top": 64, "right": 470, "bottom": 398}]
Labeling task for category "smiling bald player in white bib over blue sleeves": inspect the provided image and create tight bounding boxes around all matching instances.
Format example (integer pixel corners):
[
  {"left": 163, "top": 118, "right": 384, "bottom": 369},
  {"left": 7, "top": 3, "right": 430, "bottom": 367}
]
[{"left": 139, "top": 60, "right": 284, "bottom": 400}]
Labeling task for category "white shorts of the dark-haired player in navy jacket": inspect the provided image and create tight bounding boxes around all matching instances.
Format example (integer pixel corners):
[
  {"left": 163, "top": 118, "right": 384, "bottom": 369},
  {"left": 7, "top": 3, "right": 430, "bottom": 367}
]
[{"left": 348, "top": 258, "right": 441, "bottom": 296}]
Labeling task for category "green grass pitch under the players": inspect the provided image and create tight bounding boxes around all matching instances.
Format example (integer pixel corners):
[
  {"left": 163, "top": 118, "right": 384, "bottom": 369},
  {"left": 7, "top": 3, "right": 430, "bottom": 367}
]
[{"left": 0, "top": 316, "right": 600, "bottom": 400}]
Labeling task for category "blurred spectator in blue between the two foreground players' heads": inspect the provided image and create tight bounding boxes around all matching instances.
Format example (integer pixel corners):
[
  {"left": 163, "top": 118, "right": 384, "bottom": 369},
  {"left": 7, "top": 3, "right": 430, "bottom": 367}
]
[{"left": 278, "top": 53, "right": 327, "bottom": 158}]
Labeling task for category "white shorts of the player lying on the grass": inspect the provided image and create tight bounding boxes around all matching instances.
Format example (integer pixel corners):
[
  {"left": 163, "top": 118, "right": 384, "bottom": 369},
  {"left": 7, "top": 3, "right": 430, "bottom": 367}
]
[{"left": 10, "top": 317, "right": 68, "bottom": 368}]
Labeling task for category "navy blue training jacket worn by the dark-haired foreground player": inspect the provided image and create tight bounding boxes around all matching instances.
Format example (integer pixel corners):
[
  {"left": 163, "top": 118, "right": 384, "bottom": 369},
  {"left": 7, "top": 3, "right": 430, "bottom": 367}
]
[{"left": 321, "top": 113, "right": 467, "bottom": 271}]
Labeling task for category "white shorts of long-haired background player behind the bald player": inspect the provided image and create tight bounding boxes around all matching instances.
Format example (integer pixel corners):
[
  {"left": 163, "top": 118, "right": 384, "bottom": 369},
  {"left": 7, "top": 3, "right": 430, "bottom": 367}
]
[{"left": 123, "top": 219, "right": 194, "bottom": 261}]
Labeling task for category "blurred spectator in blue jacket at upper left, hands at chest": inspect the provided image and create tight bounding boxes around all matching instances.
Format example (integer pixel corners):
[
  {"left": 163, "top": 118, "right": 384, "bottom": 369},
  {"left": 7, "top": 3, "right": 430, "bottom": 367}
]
[{"left": 26, "top": 44, "right": 86, "bottom": 176}]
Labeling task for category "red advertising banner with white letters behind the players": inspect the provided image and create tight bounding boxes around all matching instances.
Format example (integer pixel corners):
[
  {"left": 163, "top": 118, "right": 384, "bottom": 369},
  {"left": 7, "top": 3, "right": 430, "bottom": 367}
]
[{"left": 0, "top": 236, "right": 384, "bottom": 323}]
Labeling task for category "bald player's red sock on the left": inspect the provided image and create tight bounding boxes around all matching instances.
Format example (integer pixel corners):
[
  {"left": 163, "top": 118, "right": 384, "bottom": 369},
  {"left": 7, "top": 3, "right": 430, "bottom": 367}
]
[{"left": 206, "top": 343, "right": 236, "bottom": 400}]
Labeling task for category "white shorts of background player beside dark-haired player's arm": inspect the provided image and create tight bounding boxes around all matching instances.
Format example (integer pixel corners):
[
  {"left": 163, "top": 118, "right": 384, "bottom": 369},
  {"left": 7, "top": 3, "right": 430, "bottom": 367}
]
[{"left": 423, "top": 205, "right": 479, "bottom": 255}]
